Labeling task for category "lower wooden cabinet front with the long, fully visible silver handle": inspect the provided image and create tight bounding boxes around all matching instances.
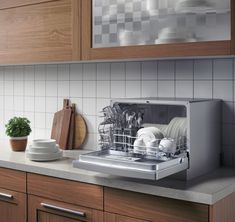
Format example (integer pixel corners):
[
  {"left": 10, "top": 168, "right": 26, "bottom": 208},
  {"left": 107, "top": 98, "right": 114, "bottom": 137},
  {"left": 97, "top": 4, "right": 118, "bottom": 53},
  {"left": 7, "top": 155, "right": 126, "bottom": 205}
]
[{"left": 28, "top": 195, "right": 103, "bottom": 222}]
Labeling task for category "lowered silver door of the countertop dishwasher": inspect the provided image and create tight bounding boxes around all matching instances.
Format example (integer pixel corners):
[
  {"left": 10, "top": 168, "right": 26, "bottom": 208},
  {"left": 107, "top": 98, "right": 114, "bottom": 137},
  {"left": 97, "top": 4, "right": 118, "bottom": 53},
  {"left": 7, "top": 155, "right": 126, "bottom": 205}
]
[{"left": 73, "top": 149, "right": 189, "bottom": 180}]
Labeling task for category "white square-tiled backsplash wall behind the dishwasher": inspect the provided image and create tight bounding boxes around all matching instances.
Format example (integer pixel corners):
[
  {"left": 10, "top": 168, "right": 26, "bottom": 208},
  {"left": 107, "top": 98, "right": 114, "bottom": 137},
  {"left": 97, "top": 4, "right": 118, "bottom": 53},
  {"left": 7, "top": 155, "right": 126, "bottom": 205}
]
[{"left": 0, "top": 58, "right": 235, "bottom": 166}]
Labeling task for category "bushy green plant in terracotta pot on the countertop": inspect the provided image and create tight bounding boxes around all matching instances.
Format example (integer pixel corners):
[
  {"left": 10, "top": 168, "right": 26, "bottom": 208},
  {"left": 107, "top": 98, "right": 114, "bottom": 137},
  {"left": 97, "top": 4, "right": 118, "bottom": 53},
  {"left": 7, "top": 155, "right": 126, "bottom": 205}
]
[{"left": 5, "top": 117, "right": 32, "bottom": 151}]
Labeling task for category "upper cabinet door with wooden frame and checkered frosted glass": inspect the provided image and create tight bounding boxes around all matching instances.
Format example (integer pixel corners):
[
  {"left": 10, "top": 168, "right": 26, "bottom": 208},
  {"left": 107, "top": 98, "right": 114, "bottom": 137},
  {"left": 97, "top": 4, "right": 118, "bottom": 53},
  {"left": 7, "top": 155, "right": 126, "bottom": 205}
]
[{"left": 82, "top": 0, "right": 235, "bottom": 60}]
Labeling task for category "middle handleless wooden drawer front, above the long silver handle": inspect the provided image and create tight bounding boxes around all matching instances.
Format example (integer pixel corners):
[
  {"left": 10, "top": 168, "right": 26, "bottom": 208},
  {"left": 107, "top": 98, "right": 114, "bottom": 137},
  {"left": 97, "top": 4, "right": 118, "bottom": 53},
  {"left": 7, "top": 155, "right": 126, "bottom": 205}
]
[{"left": 27, "top": 174, "right": 103, "bottom": 210}]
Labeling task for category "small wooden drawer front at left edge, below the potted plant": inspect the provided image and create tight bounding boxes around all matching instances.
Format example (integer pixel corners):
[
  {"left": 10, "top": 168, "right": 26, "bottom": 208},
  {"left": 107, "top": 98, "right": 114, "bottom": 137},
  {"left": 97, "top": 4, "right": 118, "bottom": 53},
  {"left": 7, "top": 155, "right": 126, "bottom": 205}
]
[{"left": 0, "top": 168, "right": 26, "bottom": 193}]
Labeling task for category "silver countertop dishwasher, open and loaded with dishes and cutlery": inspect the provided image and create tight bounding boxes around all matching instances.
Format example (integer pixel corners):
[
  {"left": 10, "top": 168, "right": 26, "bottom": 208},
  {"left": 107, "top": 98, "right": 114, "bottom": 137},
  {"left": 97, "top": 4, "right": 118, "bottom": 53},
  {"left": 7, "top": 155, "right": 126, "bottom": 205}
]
[{"left": 73, "top": 98, "right": 221, "bottom": 180}]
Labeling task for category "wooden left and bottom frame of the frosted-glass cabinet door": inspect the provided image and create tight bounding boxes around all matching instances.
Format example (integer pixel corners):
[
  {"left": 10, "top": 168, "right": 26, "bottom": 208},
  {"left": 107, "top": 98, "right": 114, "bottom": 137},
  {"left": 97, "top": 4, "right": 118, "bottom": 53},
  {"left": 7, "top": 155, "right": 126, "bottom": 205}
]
[{"left": 82, "top": 0, "right": 231, "bottom": 60}]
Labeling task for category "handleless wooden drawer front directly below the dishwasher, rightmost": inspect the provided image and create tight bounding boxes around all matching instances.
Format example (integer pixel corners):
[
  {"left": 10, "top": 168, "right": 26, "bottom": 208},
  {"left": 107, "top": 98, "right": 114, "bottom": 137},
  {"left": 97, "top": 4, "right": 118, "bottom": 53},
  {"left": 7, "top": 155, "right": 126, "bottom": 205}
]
[{"left": 104, "top": 188, "right": 209, "bottom": 222}]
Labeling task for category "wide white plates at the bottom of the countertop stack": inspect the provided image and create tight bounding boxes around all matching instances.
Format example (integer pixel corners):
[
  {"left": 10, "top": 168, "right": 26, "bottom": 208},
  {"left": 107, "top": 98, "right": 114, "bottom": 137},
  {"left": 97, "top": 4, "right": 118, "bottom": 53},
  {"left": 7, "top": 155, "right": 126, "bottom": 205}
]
[{"left": 26, "top": 150, "right": 63, "bottom": 162}]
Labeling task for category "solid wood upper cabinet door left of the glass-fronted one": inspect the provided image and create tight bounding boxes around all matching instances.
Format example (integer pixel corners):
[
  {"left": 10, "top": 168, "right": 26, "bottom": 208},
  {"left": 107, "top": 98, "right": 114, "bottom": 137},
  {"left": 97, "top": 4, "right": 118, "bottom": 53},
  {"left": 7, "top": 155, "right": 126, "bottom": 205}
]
[{"left": 0, "top": 0, "right": 81, "bottom": 64}]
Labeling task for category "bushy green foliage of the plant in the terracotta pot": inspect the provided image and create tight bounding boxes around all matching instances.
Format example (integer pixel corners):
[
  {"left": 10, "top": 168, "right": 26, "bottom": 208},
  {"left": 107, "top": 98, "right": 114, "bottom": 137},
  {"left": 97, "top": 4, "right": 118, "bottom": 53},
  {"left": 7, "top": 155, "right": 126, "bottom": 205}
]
[{"left": 5, "top": 117, "right": 32, "bottom": 137}]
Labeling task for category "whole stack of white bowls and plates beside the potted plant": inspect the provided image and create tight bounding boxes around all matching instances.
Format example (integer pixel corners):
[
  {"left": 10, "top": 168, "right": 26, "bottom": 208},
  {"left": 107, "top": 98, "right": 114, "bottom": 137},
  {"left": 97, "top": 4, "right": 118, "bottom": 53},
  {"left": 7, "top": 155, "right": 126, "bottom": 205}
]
[{"left": 26, "top": 139, "right": 62, "bottom": 161}]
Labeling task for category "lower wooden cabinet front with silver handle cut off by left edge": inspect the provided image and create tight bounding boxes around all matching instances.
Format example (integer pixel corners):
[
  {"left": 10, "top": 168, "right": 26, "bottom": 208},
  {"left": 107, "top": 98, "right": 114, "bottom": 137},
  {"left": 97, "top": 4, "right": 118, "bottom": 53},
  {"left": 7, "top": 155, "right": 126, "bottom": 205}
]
[{"left": 0, "top": 189, "right": 27, "bottom": 222}]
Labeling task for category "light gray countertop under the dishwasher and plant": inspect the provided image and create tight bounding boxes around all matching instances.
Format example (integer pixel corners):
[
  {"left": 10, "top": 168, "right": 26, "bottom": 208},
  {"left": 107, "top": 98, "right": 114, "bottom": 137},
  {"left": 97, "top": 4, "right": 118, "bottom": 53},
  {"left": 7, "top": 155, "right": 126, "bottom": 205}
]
[{"left": 0, "top": 143, "right": 235, "bottom": 205}]
